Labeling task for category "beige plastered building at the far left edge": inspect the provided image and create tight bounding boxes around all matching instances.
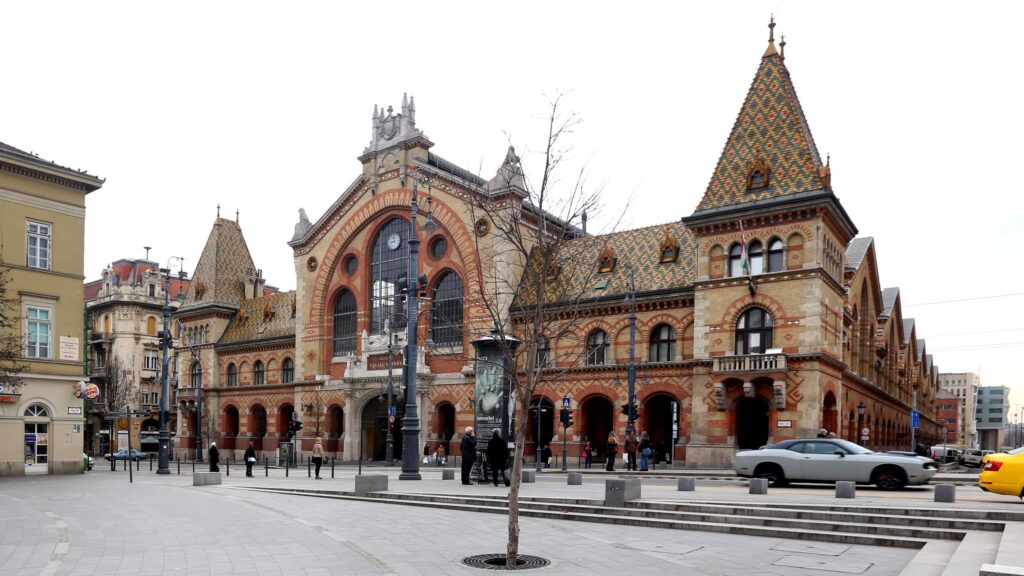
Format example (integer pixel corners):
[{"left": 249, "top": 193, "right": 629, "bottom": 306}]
[{"left": 0, "top": 142, "right": 103, "bottom": 476}]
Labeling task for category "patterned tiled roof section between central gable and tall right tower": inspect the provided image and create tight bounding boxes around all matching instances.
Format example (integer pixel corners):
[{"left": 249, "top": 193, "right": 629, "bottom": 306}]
[{"left": 516, "top": 221, "right": 695, "bottom": 306}]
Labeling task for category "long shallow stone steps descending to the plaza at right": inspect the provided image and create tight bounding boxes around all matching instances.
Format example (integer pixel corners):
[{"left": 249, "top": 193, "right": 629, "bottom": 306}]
[{"left": 234, "top": 487, "right": 1024, "bottom": 576}]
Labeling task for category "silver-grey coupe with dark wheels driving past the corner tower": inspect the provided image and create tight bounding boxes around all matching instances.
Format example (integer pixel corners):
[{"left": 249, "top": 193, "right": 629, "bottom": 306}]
[{"left": 733, "top": 439, "right": 938, "bottom": 490}]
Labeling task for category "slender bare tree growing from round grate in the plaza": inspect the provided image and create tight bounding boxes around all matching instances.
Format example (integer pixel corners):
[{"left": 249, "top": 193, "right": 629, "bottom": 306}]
[{"left": 469, "top": 95, "right": 614, "bottom": 568}]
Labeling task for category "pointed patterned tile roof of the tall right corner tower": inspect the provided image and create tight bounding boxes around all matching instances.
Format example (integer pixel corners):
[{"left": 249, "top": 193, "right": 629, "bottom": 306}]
[{"left": 696, "top": 30, "right": 829, "bottom": 213}]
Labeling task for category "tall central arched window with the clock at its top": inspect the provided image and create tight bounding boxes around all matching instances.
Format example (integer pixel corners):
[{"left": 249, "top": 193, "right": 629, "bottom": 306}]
[{"left": 370, "top": 218, "right": 409, "bottom": 334}]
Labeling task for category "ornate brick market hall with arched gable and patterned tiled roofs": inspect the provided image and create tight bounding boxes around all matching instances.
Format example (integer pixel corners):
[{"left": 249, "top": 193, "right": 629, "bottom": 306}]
[{"left": 179, "top": 20, "right": 941, "bottom": 465}]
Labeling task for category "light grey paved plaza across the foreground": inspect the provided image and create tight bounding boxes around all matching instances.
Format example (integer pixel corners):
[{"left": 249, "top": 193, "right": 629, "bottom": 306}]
[{"left": 0, "top": 462, "right": 1018, "bottom": 576}]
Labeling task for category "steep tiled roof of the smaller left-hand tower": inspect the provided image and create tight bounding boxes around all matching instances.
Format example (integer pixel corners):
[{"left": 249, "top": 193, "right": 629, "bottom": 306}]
[{"left": 179, "top": 218, "right": 256, "bottom": 312}]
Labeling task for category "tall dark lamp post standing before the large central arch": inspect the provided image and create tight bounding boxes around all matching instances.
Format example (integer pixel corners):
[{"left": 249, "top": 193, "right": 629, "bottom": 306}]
[{"left": 398, "top": 180, "right": 421, "bottom": 480}]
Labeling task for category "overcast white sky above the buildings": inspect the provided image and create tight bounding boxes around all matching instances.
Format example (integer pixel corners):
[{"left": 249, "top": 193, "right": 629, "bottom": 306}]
[{"left": 0, "top": 1, "right": 1024, "bottom": 419}]
